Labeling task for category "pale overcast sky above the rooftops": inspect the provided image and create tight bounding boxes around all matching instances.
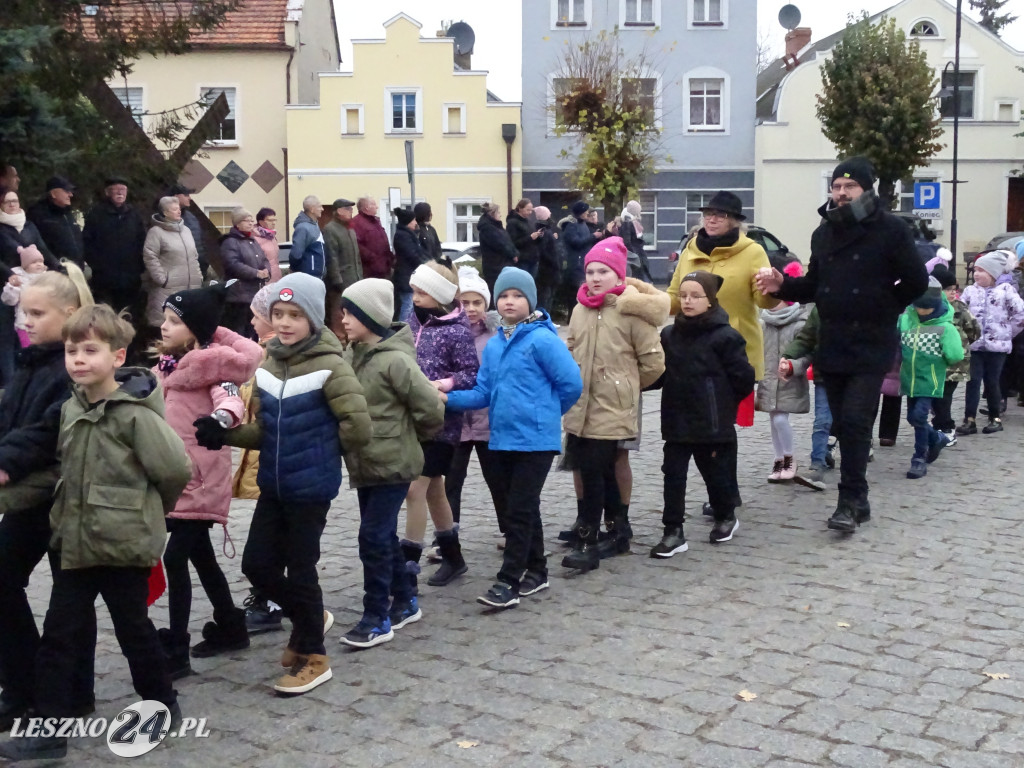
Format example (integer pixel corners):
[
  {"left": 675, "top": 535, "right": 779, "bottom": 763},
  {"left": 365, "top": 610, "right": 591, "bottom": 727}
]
[{"left": 334, "top": 0, "right": 1024, "bottom": 101}]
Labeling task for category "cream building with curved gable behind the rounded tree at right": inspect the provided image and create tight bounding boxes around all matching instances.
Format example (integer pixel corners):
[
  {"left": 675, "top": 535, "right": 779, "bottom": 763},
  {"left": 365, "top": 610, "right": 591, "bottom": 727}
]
[{"left": 755, "top": 0, "right": 1024, "bottom": 265}]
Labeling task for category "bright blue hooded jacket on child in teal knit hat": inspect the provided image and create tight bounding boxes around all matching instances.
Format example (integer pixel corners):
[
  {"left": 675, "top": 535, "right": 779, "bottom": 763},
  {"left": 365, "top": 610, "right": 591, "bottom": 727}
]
[{"left": 447, "top": 309, "right": 583, "bottom": 453}]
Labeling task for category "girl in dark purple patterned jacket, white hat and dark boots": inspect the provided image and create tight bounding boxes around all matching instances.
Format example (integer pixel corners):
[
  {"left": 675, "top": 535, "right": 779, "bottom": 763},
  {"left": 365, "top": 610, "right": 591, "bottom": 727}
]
[{"left": 401, "top": 262, "right": 480, "bottom": 591}]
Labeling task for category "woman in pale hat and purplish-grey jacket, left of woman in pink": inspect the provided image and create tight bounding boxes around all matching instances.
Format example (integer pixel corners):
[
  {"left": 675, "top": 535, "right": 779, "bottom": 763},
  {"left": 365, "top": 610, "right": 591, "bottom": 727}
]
[{"left": 220, "top": 208, "right": 270, "bottom": 341}]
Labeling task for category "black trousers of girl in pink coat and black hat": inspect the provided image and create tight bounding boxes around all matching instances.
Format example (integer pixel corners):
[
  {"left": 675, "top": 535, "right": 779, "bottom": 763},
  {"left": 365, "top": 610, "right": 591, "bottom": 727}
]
[{"left": 164, "top": 517, "right": 234, "bottom": 642}]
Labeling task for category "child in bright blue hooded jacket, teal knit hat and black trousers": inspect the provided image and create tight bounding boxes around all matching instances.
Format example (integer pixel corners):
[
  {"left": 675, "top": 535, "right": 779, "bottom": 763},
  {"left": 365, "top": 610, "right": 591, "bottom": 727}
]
[{"left": 441, "top": 266, "right": 583, "bottom": 608}]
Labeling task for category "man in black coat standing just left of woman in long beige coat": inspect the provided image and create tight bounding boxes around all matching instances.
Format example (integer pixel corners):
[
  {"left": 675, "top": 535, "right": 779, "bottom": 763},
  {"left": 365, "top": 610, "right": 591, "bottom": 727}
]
[{"left": 82, "top": 176, "right": 145, "bottom": 319}]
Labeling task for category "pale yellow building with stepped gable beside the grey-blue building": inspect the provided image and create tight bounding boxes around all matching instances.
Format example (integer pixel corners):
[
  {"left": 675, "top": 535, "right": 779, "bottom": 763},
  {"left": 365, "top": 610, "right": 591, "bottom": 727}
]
[{"left": 287, "top": 13, "right": 522, "bottom": 243}]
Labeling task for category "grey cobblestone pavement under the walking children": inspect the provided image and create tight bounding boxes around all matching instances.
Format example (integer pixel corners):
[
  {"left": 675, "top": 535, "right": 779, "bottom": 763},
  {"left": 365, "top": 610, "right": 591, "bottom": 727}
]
[{"left": 6, "top": 395, "right": 1024, "bottom": 768}]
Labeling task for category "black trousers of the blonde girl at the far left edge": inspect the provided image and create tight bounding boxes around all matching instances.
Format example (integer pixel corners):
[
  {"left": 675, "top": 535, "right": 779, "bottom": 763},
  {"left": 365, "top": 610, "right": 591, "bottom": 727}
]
[{"left": 0, "top": 507, "right": 96, "bottom": 709}]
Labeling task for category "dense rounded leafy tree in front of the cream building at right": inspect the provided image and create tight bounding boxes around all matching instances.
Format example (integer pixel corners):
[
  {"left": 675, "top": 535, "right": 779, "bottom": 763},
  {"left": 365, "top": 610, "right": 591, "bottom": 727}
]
[{"left": 816, "top": 13, "right": 942, "bottom": 205}]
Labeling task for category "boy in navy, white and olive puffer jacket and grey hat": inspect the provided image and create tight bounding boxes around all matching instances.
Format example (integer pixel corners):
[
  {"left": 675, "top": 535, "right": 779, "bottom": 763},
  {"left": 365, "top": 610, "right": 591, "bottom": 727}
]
[{"left": 196, "top": 273, "right": 371, "bottom": 693}]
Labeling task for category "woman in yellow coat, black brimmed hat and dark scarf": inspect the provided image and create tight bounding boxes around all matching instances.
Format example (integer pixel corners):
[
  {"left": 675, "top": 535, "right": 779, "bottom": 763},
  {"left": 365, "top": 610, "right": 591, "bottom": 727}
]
[{"left": 669, "top": 191, "right": 778, "bottom": 381}]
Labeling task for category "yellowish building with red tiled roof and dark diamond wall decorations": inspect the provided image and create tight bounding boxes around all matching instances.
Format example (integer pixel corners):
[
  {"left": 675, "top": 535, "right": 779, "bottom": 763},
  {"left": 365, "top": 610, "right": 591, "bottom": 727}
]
[{"left": 110, "top": 0, "right": 340, "bottom": 231}]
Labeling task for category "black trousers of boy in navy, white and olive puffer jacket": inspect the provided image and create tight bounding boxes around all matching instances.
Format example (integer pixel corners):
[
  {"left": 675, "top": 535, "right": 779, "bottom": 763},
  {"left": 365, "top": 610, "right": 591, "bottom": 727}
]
[{"left": 242, "top": 499, "right": 331, "bottom": 655}]
